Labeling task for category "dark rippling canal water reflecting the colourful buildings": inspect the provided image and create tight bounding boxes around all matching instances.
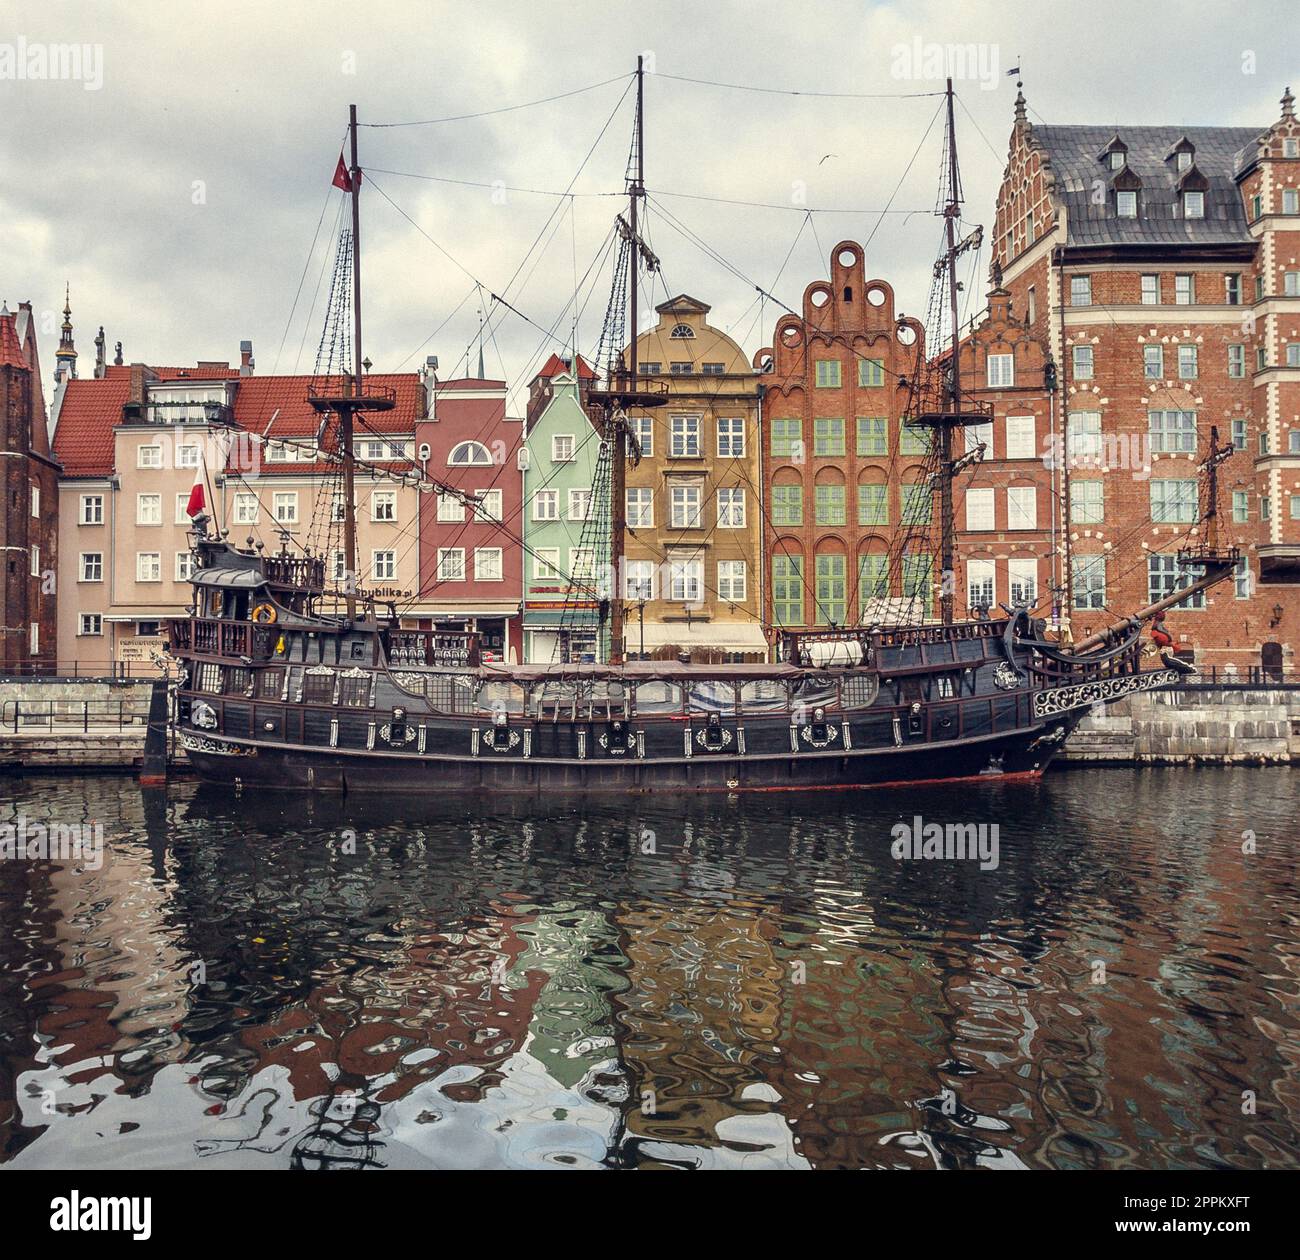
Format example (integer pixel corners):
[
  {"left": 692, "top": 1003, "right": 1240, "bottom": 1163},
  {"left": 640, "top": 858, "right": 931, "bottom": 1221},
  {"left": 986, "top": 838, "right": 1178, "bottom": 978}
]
[{"left": 0, "top": 768, "right": 1300, "bottom": 1169}]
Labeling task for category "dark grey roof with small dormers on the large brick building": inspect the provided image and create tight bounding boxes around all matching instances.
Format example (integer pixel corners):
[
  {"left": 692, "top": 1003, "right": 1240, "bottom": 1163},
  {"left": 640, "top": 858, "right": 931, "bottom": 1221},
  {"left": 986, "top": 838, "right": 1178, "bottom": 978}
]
[{"left": 1034, "top": 126, "right": 1264, "bottom": 246}]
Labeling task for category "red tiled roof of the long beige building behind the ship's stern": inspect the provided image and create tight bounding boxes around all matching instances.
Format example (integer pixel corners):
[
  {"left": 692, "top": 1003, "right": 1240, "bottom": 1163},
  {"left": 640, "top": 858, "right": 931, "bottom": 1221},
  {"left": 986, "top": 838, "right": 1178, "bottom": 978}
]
[{"left": 55, "top": 365, "right": 424, "bottom": 477}]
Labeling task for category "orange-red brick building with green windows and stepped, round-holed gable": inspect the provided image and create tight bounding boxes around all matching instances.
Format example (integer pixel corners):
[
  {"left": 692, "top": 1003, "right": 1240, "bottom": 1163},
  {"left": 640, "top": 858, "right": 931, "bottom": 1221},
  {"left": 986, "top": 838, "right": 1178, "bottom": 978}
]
[{"left": 754, "top": 241, "right": 936, "bottom": 628}]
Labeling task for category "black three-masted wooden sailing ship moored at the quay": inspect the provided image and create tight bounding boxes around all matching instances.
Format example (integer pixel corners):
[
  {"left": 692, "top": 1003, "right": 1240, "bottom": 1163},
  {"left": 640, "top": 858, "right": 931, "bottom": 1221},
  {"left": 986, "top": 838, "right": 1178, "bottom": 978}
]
[{"left": 166, "top": 71, "right": 1238, "bottom": 793}]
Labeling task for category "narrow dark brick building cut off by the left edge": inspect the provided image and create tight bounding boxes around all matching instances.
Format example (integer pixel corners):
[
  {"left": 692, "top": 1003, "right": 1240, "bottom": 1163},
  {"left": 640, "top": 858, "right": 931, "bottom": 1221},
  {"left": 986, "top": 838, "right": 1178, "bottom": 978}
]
[{"left": 0, "top": 302, "right": 59, "bottom": 674}]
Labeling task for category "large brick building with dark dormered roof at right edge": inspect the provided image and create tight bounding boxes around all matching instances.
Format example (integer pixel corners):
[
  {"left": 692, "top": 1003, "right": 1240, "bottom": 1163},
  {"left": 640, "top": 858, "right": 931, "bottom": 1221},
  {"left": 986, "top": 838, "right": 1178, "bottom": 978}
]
[{"left": 993, "top": 90, "right": 1300, "bottom": 668}]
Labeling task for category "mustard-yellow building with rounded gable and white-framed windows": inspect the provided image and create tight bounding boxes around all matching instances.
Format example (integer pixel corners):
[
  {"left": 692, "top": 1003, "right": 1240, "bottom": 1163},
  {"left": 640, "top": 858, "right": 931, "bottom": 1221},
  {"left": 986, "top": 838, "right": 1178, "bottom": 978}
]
[{"left": 623, "top": 294, "right": 767, "bottom": 661}]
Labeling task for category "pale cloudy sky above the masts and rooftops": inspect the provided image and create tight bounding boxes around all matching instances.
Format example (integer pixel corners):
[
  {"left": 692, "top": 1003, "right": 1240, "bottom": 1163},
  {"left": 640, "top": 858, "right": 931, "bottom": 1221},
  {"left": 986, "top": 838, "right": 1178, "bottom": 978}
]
[{"left": 0, "top": 0, "right": 1300, "bottom": 410}]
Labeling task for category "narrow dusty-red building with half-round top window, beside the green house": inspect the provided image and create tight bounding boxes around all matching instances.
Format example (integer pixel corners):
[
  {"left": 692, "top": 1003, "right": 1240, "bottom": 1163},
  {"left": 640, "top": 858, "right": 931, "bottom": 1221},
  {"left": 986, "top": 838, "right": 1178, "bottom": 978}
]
[{"left": 412, "top": 374, "right": 524, "bottom": 661}]
